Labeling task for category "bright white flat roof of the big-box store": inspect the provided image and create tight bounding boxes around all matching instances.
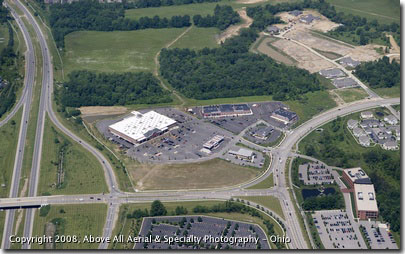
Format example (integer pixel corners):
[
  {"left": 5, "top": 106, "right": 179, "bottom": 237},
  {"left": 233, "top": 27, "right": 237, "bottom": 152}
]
[{"left": 109, "top": 111, "right": 176, "bottom": 141}]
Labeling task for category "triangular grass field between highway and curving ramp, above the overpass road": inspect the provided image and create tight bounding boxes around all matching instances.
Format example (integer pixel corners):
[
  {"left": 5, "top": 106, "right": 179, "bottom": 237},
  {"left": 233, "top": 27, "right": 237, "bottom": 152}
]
[{"left": 38, "top": 117, "right": 108, "bottom": 195}]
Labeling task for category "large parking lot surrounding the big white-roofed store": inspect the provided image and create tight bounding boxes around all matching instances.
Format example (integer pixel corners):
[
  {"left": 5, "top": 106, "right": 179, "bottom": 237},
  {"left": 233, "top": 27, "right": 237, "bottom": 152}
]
[{"left": 97, "top": 108, "right": 232, "bottom": 163}]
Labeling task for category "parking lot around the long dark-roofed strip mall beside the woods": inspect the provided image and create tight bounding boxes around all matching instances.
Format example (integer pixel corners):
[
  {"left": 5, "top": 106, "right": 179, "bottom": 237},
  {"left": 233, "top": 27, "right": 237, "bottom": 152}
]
[{"left": 192, "top": 102, "right": 293, "bottom": 134}]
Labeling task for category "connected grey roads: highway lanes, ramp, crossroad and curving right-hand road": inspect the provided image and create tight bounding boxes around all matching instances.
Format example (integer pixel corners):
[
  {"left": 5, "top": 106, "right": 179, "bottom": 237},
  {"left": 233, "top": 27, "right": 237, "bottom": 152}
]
[{"left": 0, "top": 1, "right": 400, "bottom": 249}]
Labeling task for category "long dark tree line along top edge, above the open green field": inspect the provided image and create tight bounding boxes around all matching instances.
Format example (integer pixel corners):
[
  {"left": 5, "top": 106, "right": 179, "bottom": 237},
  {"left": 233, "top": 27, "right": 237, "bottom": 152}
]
[{"left": 49, "top": 0, "right": 239, "bottom": 48}]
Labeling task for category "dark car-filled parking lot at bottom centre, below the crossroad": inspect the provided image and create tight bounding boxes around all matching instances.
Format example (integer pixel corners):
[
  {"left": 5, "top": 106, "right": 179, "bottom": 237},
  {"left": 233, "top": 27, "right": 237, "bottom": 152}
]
[{"left": 135, "top": 216, "right": 270, "bottom": 249}]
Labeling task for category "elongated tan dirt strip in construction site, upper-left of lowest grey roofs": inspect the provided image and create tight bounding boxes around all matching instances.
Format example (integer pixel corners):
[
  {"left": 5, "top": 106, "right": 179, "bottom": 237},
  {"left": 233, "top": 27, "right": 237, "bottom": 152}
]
[{"left": 272, "top": 37, "right": 334, "bottom": 73}]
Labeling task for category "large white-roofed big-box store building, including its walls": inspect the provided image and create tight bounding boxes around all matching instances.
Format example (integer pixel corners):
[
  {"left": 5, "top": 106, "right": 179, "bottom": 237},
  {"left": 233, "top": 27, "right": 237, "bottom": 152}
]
[{"left": 108, "top": 111, "right": 177, "bottom": 144}]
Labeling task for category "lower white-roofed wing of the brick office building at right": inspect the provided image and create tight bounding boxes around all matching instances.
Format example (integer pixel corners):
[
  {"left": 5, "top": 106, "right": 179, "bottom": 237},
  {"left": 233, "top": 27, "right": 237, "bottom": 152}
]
[{"left": 354, "top": 184, "right": 378, "bottom": 220}]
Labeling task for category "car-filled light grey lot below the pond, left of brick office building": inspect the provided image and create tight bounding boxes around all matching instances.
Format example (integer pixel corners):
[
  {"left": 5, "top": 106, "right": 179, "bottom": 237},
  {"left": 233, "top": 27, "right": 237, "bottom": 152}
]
[{"left": 312, "top": 210, "right": 366, "bottom": 249}]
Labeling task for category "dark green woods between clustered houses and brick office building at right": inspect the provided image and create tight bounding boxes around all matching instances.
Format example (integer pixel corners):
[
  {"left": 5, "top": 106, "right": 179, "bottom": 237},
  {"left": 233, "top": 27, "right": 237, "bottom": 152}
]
[{"left": 300, "top": 118, "right": 401, "bottom": 232}]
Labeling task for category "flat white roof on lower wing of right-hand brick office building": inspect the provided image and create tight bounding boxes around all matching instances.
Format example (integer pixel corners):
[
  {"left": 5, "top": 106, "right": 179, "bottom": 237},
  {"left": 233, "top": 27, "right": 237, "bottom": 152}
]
[{"left": 354, "top": 184, "right": 378, "bottom": 212}]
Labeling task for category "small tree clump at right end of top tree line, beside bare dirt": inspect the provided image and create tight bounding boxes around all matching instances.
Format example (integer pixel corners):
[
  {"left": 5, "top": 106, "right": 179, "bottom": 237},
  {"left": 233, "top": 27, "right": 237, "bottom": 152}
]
[{"left": 193, "top": 5, "right": 240, "bottom": 30}]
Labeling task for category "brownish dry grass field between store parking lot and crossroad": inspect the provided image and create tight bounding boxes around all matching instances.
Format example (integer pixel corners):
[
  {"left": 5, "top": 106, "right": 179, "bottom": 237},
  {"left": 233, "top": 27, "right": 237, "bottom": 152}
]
[{"left": 127, "top": 159, "right": 262, "bottom": 190}]
